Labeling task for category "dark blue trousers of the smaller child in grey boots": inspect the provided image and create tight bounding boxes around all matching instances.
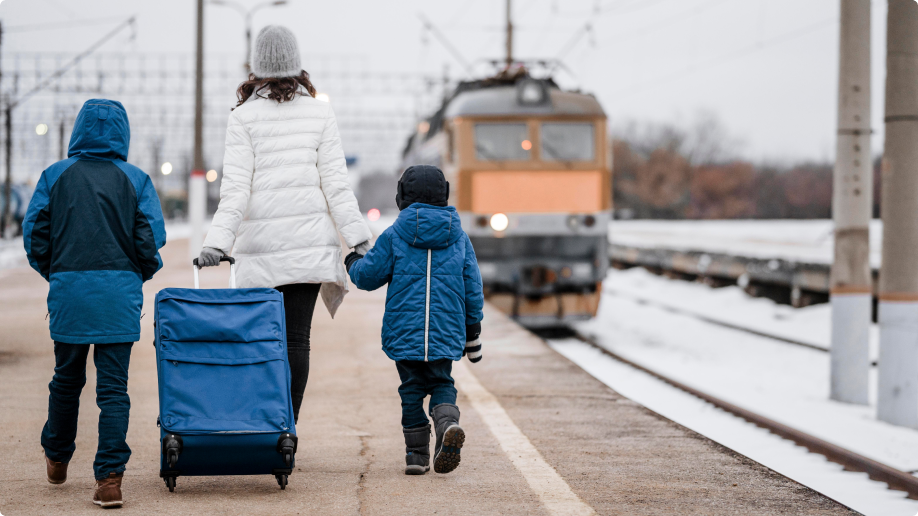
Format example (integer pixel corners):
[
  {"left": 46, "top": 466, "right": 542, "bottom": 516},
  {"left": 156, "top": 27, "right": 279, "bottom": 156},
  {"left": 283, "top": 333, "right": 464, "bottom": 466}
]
[{"left": 395, "top": 358, "right": 456, "bottom": 428}]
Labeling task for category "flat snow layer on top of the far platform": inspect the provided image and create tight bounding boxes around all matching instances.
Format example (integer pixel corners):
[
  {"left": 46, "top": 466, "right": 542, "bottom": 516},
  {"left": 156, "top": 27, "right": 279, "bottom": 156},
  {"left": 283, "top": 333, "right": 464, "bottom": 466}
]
[{"left": 609, "top": 220, "right": 883, "bottom": 267}]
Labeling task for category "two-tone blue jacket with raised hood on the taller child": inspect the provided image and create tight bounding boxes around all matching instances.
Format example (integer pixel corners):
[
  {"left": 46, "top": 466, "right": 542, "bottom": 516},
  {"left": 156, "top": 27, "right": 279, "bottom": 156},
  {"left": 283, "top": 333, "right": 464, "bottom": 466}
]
[{"left": 22, "top": 99, "right": 166, "bottom": 344}]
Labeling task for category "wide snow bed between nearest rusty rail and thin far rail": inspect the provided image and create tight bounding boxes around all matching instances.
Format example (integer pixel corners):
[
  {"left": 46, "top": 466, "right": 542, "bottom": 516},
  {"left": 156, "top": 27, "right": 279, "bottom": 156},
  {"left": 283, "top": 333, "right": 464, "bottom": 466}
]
[{"left": 577, "top": 270, "right": 918, "bottom": 471}]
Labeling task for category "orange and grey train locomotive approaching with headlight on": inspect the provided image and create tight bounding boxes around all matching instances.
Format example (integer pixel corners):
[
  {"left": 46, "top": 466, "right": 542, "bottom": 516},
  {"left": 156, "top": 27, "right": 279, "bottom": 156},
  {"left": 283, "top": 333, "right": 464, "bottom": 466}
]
[{"left": 401, "top": 65, "right": 612, "bottom": 328}]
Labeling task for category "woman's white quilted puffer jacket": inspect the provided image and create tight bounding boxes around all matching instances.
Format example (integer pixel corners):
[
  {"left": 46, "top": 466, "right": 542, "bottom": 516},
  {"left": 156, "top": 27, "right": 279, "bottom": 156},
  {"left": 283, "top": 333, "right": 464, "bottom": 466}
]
[{"left": 204, "top": 95, "right": 371, "bottom": 316}]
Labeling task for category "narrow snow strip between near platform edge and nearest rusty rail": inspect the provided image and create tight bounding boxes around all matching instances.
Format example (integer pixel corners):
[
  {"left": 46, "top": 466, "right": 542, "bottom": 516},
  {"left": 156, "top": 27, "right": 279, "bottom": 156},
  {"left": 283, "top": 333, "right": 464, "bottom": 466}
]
[{"left": 549, "top": 339, "right": 918, "bottom": 516}]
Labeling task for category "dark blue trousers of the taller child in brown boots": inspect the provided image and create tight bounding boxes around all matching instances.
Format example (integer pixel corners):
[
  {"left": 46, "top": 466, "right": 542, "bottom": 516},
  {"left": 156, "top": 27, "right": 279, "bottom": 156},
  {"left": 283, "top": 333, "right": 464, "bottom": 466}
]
[{"left": 41, "top": 341, "right": 134, "bottom": 480}]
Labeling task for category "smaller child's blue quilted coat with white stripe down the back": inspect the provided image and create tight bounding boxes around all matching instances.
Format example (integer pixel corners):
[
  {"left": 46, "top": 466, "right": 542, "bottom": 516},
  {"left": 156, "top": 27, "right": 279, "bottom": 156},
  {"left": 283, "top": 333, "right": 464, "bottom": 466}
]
[{"left": 349, "top": 203, "right": 484, "bottom": 361}]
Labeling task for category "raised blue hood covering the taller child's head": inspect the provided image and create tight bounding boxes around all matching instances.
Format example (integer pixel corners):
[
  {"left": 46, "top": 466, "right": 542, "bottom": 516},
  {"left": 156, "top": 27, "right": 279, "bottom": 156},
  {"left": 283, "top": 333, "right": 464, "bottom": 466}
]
[{"left": 67, "top": 99, "right": 131, "bottom": 161}]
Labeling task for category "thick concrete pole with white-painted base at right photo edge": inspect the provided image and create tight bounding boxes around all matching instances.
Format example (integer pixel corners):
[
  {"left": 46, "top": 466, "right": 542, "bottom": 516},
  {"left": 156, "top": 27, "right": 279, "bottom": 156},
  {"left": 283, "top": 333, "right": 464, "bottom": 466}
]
[{"left": 877, "top": 0, "right": 918, "bottom": 428}]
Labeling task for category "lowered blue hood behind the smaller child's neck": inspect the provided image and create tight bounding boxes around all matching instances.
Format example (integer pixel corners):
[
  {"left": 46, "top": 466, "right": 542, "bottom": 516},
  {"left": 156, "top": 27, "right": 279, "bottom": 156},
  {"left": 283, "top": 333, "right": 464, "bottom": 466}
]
[{"left": 393, "top": 202, "right": 463, "bottom": 249}]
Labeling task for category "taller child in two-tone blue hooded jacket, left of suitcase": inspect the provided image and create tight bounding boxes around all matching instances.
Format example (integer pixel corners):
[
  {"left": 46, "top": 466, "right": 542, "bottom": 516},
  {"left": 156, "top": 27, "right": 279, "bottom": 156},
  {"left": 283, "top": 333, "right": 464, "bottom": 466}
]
[{"left": 22, "top": 99, "right": 166, "bottom": 507}]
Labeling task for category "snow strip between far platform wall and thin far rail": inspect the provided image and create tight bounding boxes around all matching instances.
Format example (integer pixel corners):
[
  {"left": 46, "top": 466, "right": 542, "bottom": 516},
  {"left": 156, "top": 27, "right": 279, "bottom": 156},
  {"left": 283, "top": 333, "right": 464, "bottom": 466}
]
[{"left": 603, "top": 267, "right": 880, "bottom": 360}]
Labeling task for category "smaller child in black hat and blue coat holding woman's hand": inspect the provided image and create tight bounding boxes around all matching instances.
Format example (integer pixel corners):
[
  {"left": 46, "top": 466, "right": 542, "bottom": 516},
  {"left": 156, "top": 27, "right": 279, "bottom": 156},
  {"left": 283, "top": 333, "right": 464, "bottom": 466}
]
[{"left": 345, "top": 165, "right": 484, "bottom": 475}]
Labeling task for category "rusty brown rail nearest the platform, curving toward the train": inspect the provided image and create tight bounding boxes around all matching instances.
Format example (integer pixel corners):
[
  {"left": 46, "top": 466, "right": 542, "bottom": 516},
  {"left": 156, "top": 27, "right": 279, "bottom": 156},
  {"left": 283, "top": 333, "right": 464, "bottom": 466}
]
[{"left": 570, "top": 330, "right": 918, "bottom": 500}]
